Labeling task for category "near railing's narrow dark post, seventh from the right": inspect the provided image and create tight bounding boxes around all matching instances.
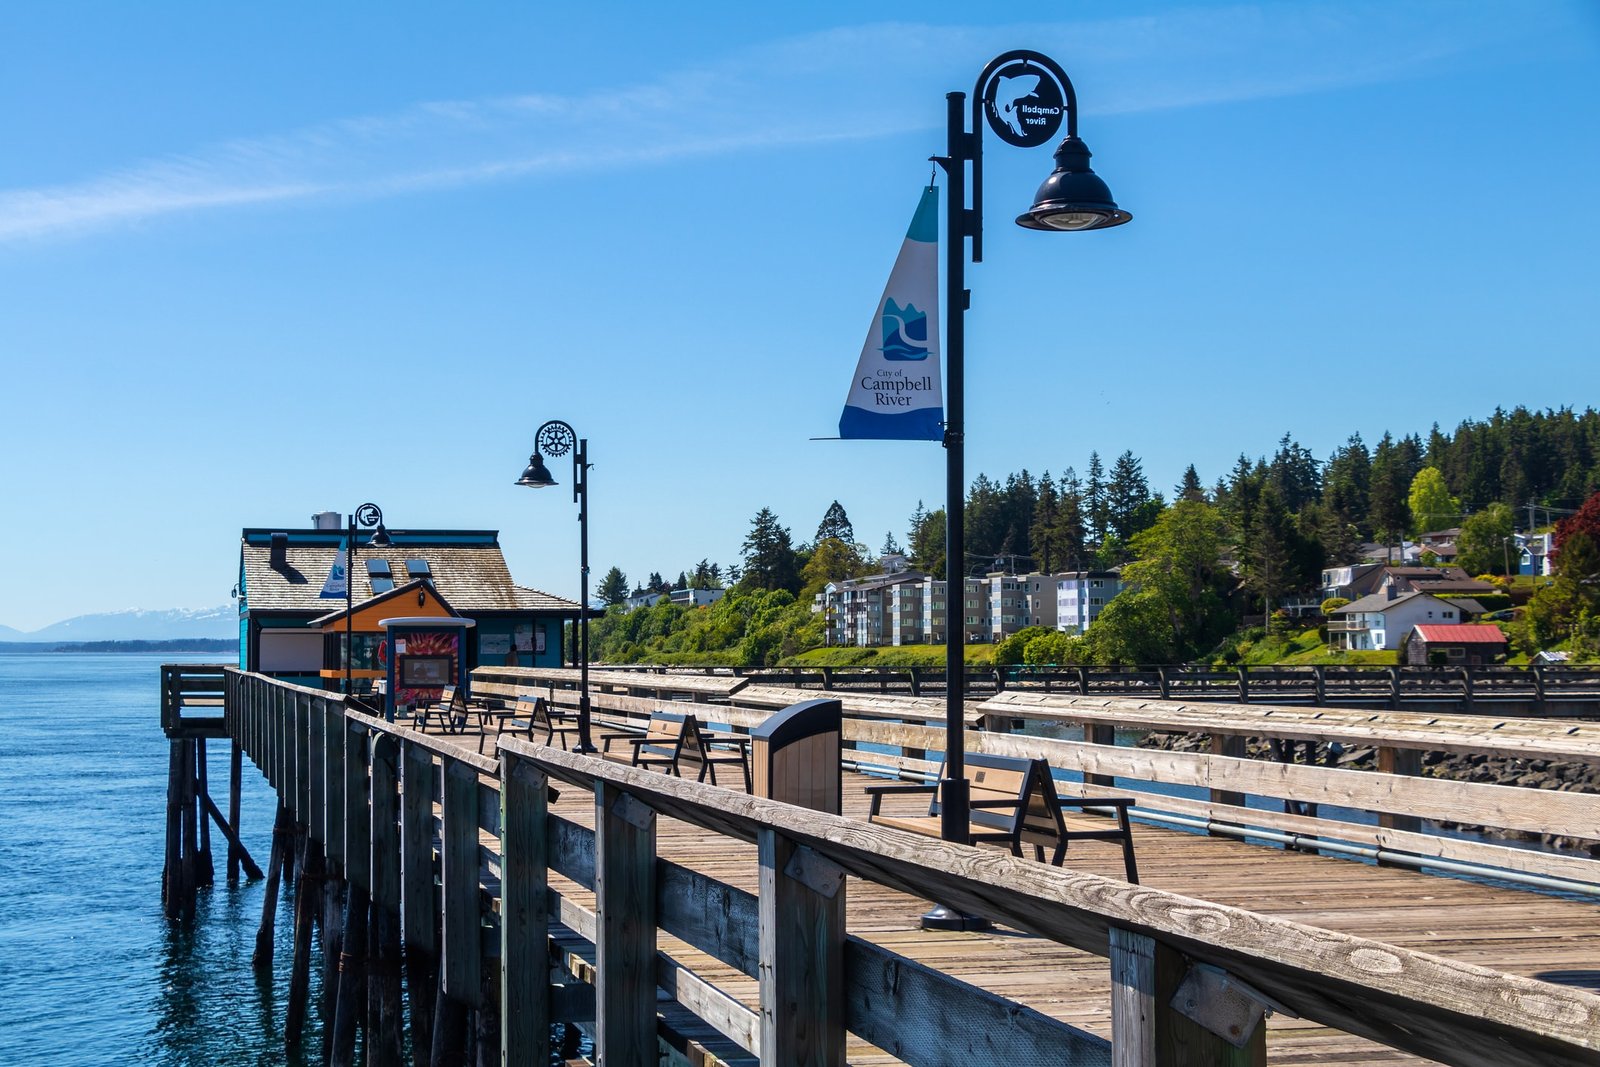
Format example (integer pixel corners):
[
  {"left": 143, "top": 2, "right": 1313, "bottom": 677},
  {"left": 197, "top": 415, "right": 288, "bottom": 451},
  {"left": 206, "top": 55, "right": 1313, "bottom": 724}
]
[{"left": 366, "top": 734, "right": 403, "bottom": 1067}]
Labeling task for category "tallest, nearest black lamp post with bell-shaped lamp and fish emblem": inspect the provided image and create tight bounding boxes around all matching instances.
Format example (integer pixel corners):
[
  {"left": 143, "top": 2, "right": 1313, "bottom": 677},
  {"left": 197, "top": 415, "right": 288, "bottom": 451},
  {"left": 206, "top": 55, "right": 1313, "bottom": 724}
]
[{"left": 922, "top": 50, "right": 1133, "bottom": 929}]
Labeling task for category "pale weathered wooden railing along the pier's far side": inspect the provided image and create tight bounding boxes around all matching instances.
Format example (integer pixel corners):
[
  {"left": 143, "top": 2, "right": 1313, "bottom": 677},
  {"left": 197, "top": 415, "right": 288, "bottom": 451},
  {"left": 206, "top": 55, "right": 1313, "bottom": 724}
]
[{"left": 502, "top": 667, "right": 1600, "bottom": 896}]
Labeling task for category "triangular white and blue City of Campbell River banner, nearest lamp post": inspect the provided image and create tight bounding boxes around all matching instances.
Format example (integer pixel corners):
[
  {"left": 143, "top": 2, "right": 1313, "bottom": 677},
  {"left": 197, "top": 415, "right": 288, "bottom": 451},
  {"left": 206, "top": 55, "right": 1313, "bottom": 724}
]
[{"left": 838, "top": 186, "right": 944, "bottom": 442}]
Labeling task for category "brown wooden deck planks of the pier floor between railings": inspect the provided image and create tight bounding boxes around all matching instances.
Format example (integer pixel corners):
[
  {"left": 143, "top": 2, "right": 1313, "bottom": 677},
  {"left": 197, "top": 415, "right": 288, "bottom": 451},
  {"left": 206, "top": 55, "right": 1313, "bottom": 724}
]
[{"left": 416, "top": 733, "right": 1600, "bottom": 1067}]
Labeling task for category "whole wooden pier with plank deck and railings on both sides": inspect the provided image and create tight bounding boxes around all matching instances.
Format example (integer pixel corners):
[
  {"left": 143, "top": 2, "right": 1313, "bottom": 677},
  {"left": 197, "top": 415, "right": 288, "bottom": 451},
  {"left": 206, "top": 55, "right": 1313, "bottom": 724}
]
[{"left": 152, "top": 669, "right": 1600, "bottom": 1067}]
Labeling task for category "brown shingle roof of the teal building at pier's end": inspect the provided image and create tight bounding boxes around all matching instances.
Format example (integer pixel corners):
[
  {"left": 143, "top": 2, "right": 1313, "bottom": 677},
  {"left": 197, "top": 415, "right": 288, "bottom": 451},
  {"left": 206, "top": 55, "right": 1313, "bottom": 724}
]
[{"left": 240, "top": 531, "right": 578, "bottom": 616}]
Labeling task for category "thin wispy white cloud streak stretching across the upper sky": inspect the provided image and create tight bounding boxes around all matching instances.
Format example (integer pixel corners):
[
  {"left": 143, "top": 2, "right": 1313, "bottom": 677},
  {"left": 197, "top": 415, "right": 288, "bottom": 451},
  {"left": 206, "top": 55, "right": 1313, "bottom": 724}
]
[{"left": 0, "top": 3, "right": 1565, "bottom": 245}]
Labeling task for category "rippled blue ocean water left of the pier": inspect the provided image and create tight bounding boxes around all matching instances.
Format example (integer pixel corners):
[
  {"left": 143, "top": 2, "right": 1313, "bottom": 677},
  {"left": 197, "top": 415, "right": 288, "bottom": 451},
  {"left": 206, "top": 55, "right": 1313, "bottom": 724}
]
[{"left": 0, "top": 654, "right": 322, "bottom": 1067}]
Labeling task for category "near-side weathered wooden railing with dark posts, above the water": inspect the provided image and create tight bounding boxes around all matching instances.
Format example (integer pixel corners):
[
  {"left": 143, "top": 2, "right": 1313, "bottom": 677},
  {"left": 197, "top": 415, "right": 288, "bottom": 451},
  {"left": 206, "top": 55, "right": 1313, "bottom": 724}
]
[{"left": 226, "top": 669, "right": 1600, "bottom": 1067}]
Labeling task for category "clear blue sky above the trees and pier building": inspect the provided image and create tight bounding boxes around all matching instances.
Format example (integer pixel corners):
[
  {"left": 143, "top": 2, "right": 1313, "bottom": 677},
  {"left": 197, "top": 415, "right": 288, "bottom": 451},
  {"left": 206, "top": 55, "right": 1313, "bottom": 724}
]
[{"left": 0, "top": 0, "right": 1600, "bottom": 630}]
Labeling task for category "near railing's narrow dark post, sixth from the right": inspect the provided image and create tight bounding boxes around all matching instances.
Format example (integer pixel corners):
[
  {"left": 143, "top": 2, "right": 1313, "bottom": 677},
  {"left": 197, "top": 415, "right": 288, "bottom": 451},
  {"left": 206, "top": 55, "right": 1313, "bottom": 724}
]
[{"left": 400, "top": 742, "right": 438, "bottom": 1067}]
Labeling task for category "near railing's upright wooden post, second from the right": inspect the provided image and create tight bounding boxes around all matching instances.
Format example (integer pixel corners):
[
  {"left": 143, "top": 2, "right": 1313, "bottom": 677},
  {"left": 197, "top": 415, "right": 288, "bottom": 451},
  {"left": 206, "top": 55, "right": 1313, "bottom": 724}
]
[{"left": 757, "top": 829, "right": 845, "bottom": 1067}]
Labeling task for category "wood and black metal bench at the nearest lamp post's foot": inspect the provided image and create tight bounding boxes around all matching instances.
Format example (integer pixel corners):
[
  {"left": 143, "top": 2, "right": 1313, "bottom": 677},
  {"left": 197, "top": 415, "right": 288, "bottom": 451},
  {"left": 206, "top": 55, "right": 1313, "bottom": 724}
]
[{"left": 867, "top": 752, "right": 1139, "bottom": 885}]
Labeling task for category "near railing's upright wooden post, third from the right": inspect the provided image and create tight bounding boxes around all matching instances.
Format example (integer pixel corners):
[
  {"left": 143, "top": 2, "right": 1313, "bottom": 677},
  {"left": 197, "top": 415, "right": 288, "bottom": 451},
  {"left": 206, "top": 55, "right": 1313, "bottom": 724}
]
[{"left": 595, "top": 782, "right": 658, "bottom": 1067}]
